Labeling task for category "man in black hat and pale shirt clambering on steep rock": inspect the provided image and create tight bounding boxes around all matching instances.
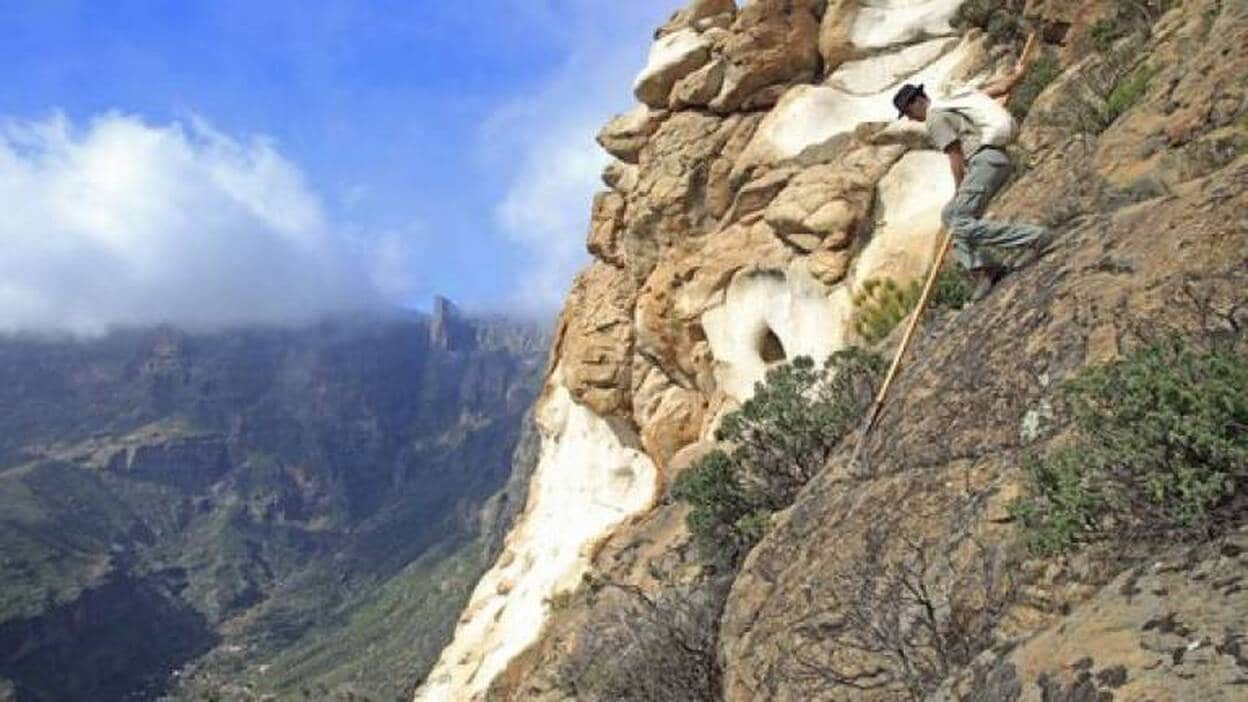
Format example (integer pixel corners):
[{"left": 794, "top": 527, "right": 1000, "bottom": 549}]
[{"left": 892, "top": 37, "right": 1052, "bottom": 301}]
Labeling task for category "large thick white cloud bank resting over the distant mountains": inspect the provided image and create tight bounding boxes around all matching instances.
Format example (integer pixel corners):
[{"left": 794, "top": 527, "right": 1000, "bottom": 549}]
[{"left": 0, "top": 114, "right": 401, "bottom": 334}]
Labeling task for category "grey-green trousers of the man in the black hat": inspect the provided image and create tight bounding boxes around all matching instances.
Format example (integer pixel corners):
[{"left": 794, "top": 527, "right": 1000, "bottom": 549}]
[{"left": 941, "top": 149, "right": 1046, "bottom": 271}]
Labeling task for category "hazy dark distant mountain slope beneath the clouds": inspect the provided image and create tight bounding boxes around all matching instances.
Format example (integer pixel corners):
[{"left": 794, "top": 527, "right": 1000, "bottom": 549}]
[{"left": 0, "top": 301, "right": 545, "bottom": 700}]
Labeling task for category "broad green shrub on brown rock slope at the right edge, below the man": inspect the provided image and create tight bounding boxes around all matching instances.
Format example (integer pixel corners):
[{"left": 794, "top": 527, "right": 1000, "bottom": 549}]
[{"left": 1012, "top": 339, "right": 1248, "bottom": 553}]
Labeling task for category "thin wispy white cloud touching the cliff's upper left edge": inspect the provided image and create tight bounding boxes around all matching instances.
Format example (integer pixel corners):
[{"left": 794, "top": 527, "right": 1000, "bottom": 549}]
[{"left": 483, "top": 0, "right": 678, "bottom": 311}]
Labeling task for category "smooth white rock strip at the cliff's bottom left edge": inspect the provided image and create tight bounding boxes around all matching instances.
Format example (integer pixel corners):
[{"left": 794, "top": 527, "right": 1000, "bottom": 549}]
[{"left": 416, "top": 371, "right": 658, "bottom": 702}]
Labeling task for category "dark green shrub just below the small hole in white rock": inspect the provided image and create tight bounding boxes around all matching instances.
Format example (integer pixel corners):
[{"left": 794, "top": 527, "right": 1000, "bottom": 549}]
[{"left": 673, "top": 349, "right": 884, "bottom": 565}]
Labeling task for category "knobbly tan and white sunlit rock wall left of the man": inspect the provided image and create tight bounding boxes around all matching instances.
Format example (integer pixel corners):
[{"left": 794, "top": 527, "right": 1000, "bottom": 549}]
[{"left": 417, "top": 0, "right": 986, "bottom": 701}]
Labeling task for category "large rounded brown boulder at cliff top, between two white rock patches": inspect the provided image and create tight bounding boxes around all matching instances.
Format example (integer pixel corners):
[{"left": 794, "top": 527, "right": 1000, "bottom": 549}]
[{"left": 710, "top": 0, "right": 821, "bottom": 112}]
